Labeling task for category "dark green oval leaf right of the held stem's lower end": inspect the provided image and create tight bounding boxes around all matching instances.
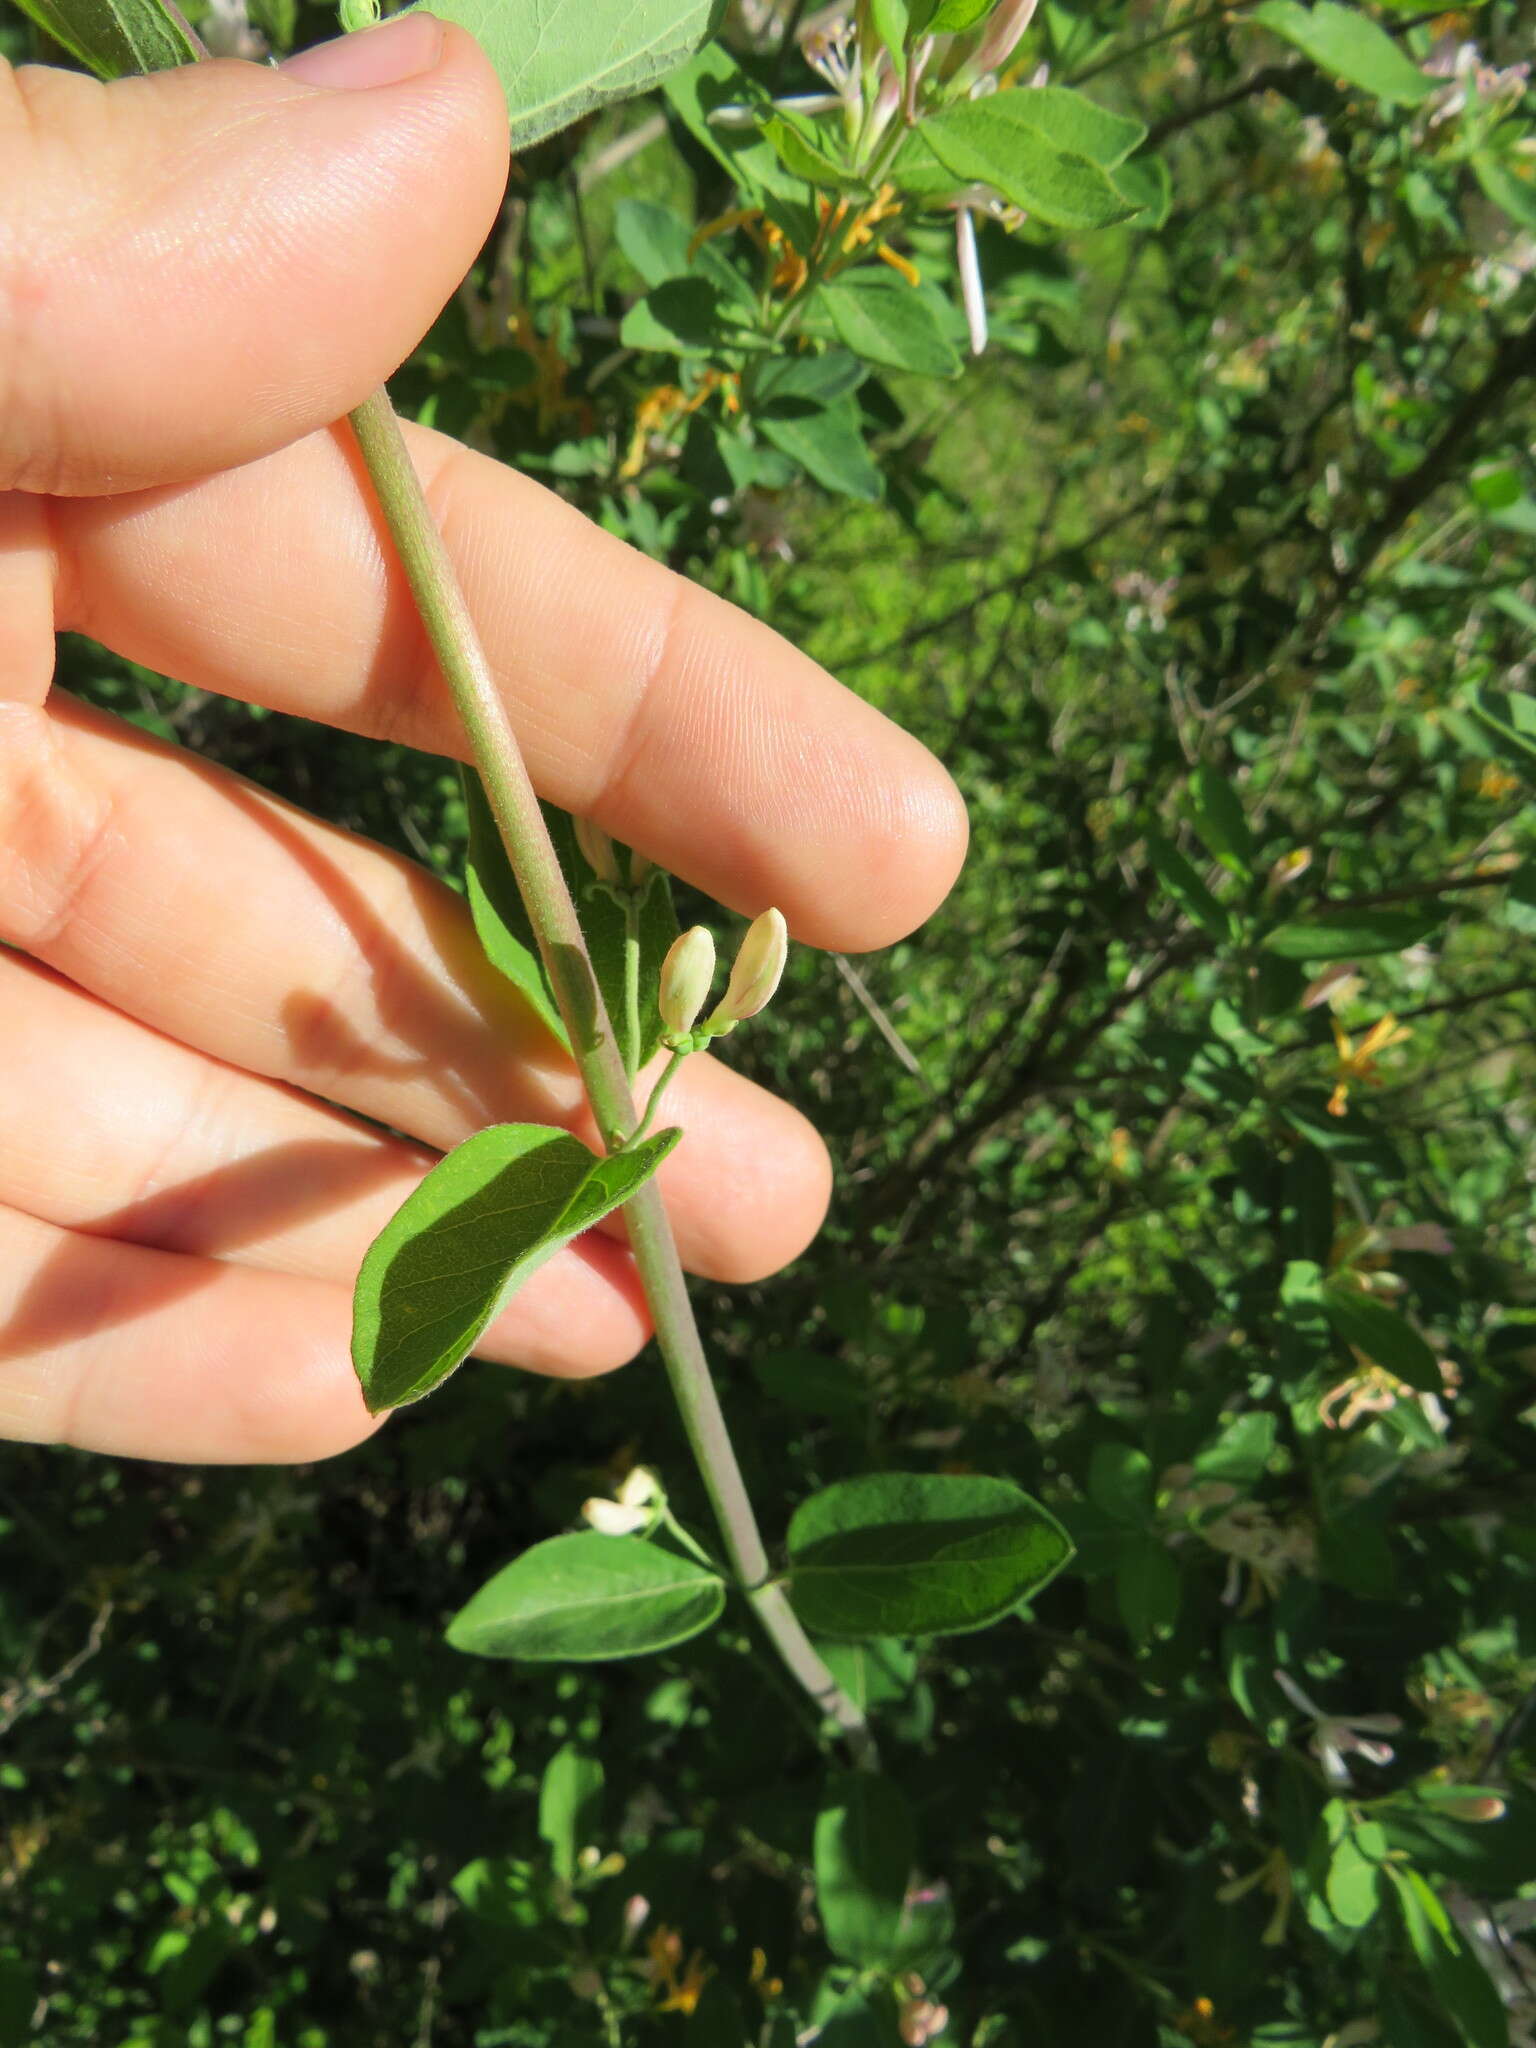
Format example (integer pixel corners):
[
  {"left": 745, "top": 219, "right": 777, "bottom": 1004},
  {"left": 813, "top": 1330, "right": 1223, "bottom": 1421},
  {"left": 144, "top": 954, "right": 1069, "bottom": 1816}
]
[{"left": 788, "top": 1473, "right": 1071, "bottom": 1636}]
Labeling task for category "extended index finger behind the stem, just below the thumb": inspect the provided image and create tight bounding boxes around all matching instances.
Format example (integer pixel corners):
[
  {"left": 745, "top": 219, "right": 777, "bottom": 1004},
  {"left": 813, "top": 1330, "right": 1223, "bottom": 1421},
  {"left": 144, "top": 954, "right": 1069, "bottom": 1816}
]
[{"left": 51, "top": 428, "right": 967, "bottom": 950}]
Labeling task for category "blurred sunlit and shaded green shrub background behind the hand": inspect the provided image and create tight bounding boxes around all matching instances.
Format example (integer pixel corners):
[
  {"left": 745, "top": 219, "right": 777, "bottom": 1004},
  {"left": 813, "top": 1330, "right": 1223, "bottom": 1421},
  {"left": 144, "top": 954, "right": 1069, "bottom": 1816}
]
[{"left": 0, "top": 0, "right": 1536, "bottom": 2048}]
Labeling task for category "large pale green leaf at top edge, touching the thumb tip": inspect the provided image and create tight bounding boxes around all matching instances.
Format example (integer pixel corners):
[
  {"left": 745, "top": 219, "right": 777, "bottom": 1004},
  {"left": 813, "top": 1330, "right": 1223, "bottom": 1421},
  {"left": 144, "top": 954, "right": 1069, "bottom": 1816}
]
[{"left": 417, "top": 0, "right": 721, "bottom": 150}]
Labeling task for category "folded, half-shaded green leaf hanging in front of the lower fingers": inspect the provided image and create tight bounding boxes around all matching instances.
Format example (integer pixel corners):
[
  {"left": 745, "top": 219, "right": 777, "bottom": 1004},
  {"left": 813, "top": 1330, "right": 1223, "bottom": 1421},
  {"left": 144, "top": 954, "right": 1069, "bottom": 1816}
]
[{"left": 352, "top": 1124, "right": 682, "bottom": 1415}]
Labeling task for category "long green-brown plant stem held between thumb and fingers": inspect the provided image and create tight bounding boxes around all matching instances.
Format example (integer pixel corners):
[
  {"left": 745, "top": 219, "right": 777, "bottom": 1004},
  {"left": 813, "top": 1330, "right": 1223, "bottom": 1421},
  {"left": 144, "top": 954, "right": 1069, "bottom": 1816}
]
[{"left": 350, "top": 389, "right": 874, "bottom": 1763}]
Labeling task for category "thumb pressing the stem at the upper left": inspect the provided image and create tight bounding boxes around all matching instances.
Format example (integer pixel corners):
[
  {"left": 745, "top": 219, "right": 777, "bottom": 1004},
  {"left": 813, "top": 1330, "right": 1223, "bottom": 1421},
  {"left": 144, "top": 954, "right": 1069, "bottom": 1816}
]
[{"left": 0, "top": 12, "right": 508, "bottom": 494}]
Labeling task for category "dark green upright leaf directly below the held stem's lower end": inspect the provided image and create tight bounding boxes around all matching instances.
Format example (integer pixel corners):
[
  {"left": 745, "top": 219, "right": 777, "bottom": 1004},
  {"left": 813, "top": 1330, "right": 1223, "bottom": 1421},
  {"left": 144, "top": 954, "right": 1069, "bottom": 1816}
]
[{"left": 815, "top": 1772, "right": 918, "bottom": 1968}]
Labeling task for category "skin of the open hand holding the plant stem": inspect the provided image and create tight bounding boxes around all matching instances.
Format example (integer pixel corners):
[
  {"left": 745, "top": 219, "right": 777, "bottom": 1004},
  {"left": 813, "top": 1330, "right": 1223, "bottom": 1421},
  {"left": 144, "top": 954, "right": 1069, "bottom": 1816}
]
[{"left": 0, "top": 14, "right": 965, "bottom": 1462}]
